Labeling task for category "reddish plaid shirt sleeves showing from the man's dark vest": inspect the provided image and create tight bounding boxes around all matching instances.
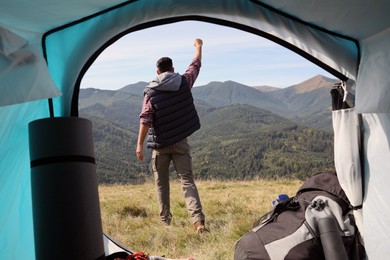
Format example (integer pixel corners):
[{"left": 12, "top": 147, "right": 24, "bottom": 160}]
[{"left": 139, "top": 58, "right": 202, "bottom": 126}]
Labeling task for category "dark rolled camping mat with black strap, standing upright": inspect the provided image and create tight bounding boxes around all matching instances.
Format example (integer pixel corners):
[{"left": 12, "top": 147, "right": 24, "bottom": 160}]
[{"left": 29, "top": 117, "right": 105, "bottom": 260}]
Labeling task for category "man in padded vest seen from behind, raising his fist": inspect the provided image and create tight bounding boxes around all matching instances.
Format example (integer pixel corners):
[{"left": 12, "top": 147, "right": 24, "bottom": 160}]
[{"left": 136, "top": 39, "right": 206, "bottom": 233}]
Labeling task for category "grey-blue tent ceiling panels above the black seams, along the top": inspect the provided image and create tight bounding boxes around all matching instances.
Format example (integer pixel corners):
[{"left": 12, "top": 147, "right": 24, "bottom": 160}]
[{"left": 0, "top": 0, "right": 390, "bottom": 39}]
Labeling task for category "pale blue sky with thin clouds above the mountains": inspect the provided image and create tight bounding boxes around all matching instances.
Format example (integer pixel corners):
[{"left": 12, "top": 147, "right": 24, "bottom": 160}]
[{"left": 81, "top": 21, "right": 334, "bottom": 90}]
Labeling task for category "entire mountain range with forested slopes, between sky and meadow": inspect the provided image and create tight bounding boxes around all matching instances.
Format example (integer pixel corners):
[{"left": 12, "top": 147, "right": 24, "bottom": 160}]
[{"left": 79, "top": 75, "right": 336, "bottom": 183}]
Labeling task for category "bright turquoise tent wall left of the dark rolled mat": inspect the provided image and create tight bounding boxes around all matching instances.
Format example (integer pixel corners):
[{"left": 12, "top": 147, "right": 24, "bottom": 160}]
[{"left": 0, "top": 100, "right": 49, "bottom": 259}]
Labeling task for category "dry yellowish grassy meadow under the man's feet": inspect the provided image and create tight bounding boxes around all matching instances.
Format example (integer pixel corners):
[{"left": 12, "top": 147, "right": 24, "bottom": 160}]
[{"left": 99, "top": 179, "right": 302, "bottom": 260}]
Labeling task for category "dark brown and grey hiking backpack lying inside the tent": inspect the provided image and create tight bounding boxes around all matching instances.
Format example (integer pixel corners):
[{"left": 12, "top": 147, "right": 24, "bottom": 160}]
[{"left": 234, "top": 171, "right": 365, "bottom": 260}]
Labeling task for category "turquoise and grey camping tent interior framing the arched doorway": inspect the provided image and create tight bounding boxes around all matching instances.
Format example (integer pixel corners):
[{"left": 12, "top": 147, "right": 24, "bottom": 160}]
[{"left": 0, "top": 0, "right": 390, "bottom": 259}]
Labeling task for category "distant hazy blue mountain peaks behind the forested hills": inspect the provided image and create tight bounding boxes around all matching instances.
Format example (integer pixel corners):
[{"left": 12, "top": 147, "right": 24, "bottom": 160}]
[{"left": 119, "top": 75, "right": 338, "bottom": 131}]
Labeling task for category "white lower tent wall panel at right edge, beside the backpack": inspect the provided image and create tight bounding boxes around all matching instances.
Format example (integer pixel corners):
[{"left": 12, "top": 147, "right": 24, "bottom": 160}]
[{"left": 362, "top": 114, "right": 390, "bottom": 259}]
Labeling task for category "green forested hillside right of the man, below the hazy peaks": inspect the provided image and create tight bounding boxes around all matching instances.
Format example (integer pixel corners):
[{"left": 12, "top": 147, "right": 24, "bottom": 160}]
[{"left": 190, "top": 105, "right": 333, "bottom": 179}]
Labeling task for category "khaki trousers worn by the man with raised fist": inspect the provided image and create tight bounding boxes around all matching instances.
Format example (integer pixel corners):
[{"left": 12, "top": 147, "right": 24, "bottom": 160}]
[{"left": 151, "top": 138, "right": 205, "bottom": 223}]
